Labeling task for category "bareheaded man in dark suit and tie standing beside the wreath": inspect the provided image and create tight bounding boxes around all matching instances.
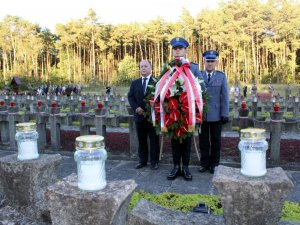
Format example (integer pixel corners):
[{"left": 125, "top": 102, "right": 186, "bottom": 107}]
[{"left": 128, "top": 60, "right": 159, "bottom": 170}]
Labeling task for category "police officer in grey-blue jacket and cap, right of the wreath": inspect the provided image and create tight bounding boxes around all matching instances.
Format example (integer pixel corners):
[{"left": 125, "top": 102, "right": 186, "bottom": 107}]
[{"left": 199, "top": 50, "right": 229, "bottom": 174}]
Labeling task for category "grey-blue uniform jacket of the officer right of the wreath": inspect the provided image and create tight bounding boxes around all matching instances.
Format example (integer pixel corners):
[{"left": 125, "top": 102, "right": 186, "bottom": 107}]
[{"left": 201, "top": 70, "right": 229, "bottom": 122}]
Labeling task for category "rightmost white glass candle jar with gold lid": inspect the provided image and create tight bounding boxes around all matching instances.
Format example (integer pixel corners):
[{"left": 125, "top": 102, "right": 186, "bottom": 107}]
[{"left": 239, "top": 128, "right": 268, "bottom": 177}]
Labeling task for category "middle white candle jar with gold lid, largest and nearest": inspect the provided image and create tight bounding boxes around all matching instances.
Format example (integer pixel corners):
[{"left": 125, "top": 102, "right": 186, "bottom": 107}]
[{"left": 74, "top": 135, "right": 107, "bottom": 191}]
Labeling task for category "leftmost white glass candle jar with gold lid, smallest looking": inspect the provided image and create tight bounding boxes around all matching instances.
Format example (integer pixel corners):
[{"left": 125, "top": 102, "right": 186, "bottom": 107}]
[{"left": 15, "top": 123, "right": 39, "bottom": 160}]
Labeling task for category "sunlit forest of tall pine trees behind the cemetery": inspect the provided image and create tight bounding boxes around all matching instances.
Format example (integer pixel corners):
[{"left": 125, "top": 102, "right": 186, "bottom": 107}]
[{"left": 0, "top": 0, "right": 300, "bottom": 89}]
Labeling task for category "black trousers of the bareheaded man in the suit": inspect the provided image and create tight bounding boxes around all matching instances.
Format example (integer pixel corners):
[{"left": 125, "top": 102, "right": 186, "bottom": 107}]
[{"left": 135, "top": 119, "right": 159, "bottom": 164}]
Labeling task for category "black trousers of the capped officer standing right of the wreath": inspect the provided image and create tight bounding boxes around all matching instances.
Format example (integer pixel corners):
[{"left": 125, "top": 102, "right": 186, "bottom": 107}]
[{"left": 199, "top": 121, "right": 222, "bottom": 167}]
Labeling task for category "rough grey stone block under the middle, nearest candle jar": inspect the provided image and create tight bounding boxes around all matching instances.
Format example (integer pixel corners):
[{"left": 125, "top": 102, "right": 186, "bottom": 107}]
[{"left": 46, "top": 174, "right": 137, "bottom": 225}]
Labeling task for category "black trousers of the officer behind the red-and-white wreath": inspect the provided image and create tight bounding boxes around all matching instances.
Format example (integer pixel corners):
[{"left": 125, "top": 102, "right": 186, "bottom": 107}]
[{"left": 171, "top": 137, "right": 192, "bottom": 166}]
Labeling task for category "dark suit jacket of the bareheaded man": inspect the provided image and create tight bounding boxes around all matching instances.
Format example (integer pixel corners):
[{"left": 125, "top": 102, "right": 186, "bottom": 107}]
[{"left": 127, "top": 76, "right": 153, "bottom": 122}]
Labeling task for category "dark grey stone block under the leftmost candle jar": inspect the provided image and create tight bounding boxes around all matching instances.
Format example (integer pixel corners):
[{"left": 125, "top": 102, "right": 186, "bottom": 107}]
[{"left": 0, "top": 154, "right": 61, "bottom": 222}]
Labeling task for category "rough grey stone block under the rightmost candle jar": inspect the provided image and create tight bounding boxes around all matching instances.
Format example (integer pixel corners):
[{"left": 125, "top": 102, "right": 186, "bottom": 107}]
[{"left": 213, "top": 166, "right": 294, "bottom": 225}]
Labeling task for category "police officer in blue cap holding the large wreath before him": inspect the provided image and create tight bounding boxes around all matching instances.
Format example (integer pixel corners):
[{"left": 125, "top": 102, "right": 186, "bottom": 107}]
[{"left": 167, "top": 37, "right": 203, "bottom": 181}]
